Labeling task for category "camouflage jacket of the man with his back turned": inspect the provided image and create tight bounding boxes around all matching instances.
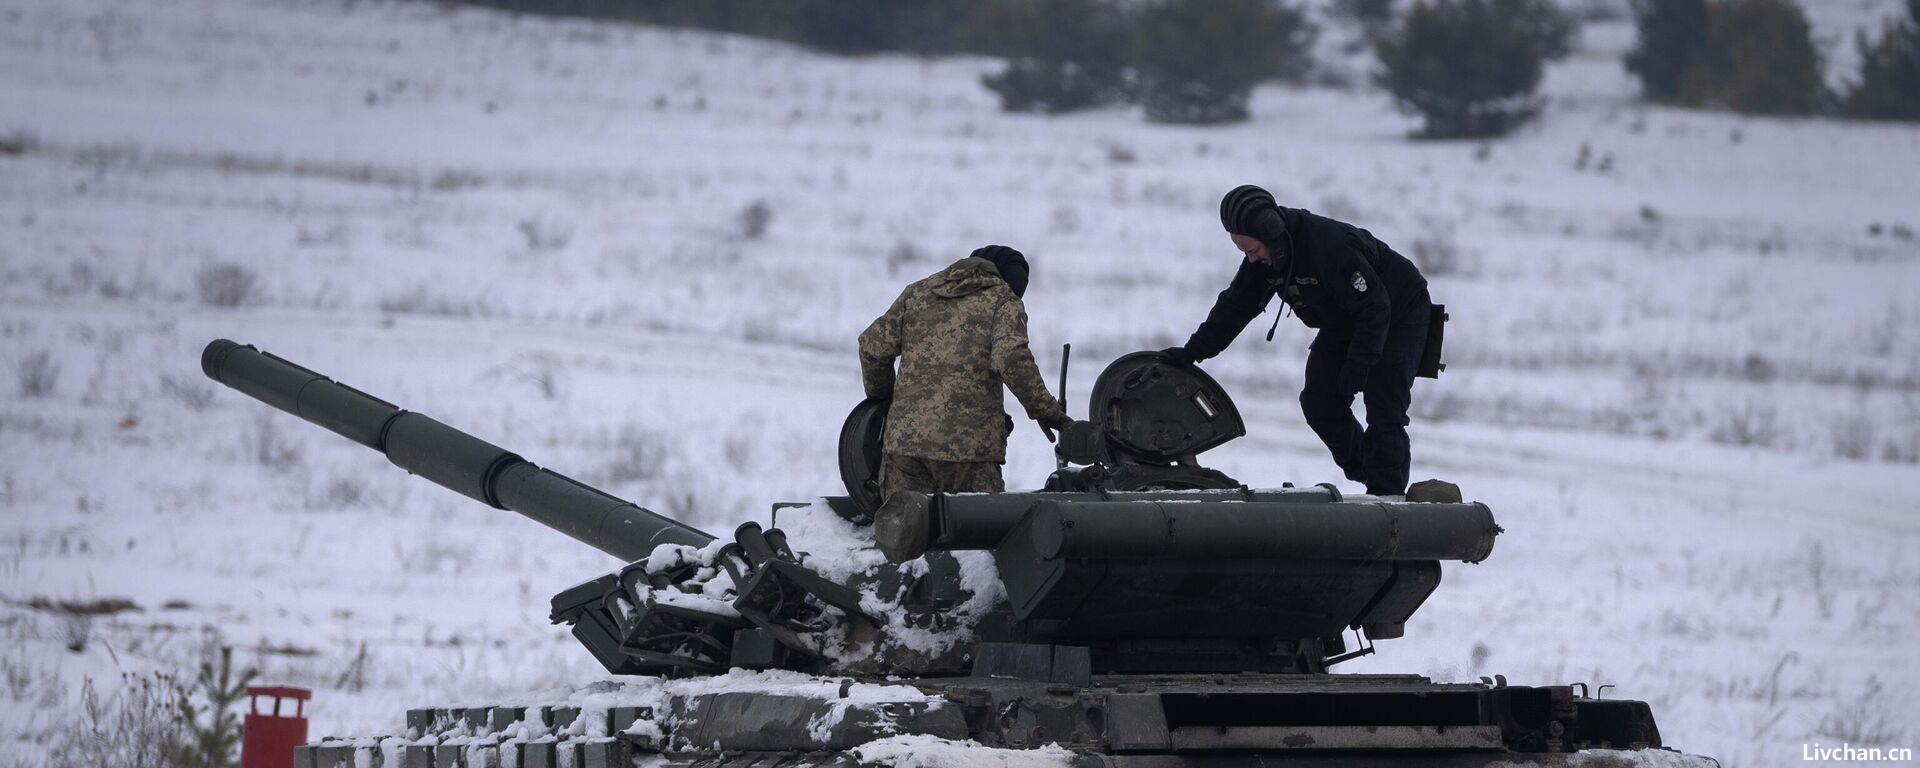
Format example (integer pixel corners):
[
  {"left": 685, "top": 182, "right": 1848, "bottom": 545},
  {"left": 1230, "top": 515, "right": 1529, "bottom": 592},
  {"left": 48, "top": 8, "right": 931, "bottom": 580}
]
[{"left": 860, "top": 257, "right": 1066, "bottom": 463}]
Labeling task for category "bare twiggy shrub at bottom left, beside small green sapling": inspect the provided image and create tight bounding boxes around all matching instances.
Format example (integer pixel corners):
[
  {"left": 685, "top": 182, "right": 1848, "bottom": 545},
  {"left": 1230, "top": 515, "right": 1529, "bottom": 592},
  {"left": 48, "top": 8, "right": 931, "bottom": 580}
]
[{"left": 48, "top": 674, "right": 192, "bottom": 768}]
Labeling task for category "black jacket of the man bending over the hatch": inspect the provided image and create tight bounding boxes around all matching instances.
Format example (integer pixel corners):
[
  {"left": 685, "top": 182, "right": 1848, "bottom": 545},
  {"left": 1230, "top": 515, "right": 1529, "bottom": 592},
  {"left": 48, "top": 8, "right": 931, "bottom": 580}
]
[{"left": 1187, "top": 207, "right": 1427, "bottom": 369}]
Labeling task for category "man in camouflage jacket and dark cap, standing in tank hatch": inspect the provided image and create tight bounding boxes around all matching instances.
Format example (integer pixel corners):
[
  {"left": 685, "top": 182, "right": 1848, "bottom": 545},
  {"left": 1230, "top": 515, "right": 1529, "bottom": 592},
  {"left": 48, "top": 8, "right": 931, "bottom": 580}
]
[{"left": 860, "top": 246, "right": 1071, "bottom": 563}]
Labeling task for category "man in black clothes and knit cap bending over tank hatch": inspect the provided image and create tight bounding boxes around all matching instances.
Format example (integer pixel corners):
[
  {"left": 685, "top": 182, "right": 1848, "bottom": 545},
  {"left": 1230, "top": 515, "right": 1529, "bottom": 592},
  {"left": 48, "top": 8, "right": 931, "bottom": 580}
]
[{"left": 1165, "top": 186, "right": 1432, "bottom": 495}]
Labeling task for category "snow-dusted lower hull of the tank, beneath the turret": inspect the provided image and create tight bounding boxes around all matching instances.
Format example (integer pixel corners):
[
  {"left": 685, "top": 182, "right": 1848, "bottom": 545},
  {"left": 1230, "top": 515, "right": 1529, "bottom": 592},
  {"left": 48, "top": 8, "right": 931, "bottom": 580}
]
[{"left": 296, "top": 674, "right": 1716, "bottom": 768}]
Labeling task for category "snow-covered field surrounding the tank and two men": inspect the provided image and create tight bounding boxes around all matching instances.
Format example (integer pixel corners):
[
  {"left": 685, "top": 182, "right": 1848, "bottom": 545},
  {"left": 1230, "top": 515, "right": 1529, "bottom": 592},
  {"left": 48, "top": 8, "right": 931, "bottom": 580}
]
[{"left": 0, "top": 0, "right": 1920, "bottom": 768}]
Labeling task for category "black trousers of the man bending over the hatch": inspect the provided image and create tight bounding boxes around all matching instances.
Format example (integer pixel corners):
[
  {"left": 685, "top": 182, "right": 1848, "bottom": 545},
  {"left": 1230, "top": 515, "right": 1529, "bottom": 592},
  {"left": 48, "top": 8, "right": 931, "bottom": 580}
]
[{"left": 1300, "top": 288, "right": 1432, "bottom": 495}]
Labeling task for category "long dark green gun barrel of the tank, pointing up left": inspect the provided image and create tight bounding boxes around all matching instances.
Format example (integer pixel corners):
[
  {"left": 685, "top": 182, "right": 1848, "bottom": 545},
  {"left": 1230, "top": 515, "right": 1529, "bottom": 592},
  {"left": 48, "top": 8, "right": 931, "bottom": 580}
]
[{"left": 200, "top": 338, "right": 714, "bottom": 561}]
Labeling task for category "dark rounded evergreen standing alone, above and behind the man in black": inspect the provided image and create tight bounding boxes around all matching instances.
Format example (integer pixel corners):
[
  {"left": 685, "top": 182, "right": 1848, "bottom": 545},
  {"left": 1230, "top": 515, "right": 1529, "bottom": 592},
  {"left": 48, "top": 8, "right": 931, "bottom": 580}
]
[{"left": 1375, "top": 0, "right": 1576, "bottom": 138}]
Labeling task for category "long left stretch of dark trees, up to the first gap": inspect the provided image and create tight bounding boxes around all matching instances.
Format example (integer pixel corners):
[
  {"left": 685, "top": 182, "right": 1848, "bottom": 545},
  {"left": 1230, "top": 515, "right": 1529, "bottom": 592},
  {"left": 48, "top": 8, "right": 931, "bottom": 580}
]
[{"left": 451, "top": 0, "right": 1315, "bottom": 123}]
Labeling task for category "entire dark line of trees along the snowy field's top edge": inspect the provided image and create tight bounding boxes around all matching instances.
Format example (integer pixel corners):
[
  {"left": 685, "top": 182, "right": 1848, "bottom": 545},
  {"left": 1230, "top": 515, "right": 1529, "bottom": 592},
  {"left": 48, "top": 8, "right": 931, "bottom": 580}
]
[{"left": 456, "top": 0, "right": 1920, "bottom": 131}]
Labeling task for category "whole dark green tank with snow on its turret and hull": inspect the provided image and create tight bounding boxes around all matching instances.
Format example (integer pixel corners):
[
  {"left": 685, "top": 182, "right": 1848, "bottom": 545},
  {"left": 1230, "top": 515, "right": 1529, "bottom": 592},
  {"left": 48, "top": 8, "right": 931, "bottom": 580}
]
[{"left": 202, "top": 340, "right": 1715, "bottom": 768}]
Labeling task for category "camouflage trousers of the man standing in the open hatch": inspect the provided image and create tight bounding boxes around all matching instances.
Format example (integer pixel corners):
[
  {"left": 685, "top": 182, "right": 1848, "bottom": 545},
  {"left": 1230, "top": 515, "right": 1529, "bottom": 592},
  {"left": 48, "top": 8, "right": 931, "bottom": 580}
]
[{"left": 874, "top": 453, "right": 1006, "bottom": 563}]
